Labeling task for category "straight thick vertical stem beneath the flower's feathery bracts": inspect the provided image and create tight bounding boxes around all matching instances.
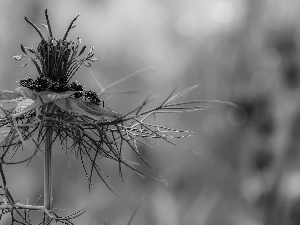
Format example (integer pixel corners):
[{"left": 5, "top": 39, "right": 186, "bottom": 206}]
[{"left": 44, "top": 109, "right": 53, "bottom": 225}]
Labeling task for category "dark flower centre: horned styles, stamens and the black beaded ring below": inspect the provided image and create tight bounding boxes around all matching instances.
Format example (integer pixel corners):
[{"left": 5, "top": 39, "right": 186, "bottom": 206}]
[{"left": 13, "top": 9, "right": 101, "bottom": 105}]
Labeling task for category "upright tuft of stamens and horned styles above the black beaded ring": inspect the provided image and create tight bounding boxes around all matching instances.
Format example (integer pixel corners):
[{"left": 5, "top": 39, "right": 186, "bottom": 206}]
[{"left": 14, "top": 9, "right": 99, "bottom": 87}]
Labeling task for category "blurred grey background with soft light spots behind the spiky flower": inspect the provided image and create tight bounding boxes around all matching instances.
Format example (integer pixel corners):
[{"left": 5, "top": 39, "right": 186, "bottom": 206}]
[{"left": 0, "top": 0, "right": 300, "bottom": 225}]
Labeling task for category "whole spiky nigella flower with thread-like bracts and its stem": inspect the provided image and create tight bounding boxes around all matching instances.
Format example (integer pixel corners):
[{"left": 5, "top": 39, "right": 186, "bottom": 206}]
[{"left": 0, "top": 10, "right": 230, "bottom": 224}]
